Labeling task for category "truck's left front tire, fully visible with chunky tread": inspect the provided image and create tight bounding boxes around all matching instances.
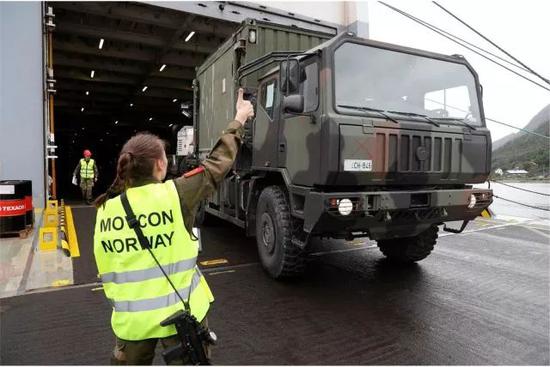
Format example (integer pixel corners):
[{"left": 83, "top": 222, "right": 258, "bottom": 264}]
[{"left": 256, "top": 186, "right": 305, "bottom": 279}]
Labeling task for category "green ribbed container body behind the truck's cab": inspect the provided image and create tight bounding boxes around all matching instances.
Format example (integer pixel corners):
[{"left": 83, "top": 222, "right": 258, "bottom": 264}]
[{"left": 194, "top": 20, "right": 335, "bottom": 155}]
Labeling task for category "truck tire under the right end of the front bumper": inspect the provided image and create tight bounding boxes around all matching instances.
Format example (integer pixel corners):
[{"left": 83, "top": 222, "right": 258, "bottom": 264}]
[{"left": 377, "top": 226, "right": 439, "bottom": 263}]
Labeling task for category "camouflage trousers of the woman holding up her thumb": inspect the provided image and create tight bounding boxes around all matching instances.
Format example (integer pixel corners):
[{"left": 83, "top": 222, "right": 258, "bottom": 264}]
[{"left": 111, "top": 318, "right": 211, "bottom": 365}]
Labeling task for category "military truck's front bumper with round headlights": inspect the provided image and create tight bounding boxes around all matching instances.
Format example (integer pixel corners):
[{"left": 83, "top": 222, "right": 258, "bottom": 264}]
[{"left": 304, "top": 188, "right": 493, "bottom": 240}]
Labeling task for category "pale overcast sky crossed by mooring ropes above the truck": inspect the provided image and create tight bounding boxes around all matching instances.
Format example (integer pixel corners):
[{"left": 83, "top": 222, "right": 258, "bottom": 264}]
[{"left": 368, "top": 0, "right": 550, "bottom": 141}]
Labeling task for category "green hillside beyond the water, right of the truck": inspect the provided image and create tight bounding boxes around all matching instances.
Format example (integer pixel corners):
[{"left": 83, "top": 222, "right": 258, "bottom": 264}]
[{"left": 493, "top": 105, "right": 550, "bottom": 176}]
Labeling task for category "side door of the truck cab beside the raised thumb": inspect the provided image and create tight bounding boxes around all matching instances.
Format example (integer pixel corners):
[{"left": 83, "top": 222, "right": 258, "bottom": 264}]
[{"left": 252, "top": 74, "right": 279, "bottom": 167}]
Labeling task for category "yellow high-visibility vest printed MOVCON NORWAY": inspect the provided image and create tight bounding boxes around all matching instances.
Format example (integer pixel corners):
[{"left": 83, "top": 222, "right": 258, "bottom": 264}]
[{"left": 94, "top": 180, "right": 214, "bottom": 340}]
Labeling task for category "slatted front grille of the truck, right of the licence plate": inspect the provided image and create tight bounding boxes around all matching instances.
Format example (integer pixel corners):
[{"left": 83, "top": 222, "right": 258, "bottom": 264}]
[{"left": 384, "top": 133, "right": 462, "bottom": 177}]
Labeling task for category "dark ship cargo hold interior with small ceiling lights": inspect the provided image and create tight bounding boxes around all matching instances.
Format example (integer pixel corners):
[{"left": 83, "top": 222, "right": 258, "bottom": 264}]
[{"left": 52, "top": 2, "right": 238, "bottom": 200}]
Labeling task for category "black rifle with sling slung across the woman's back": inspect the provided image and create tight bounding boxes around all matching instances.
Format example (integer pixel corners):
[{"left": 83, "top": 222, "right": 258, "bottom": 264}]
[{"left": 120, "top": 192, "right": 217, "bottom": 365}]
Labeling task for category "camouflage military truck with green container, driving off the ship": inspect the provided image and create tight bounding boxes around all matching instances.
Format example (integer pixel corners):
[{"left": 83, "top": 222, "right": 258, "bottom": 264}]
[{"left": 193, "top": 20, "right": 492, "bottom": 278}]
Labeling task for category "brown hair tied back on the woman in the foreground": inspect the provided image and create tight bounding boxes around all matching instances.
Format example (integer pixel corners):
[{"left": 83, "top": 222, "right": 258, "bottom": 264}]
[{"left": 94, "top": 133, "right": 166, "bottom": 208}]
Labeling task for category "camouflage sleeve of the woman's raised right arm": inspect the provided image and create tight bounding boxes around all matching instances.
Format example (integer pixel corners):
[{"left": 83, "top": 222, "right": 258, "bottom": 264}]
[{"left": 174, "top": 121, "right": 243, "bottom": 230}]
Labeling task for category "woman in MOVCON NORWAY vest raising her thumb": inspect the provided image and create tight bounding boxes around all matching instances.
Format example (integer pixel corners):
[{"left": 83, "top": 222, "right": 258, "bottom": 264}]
[{"left": 94, "top": 90, "right": 254, "bottom": 365}]
